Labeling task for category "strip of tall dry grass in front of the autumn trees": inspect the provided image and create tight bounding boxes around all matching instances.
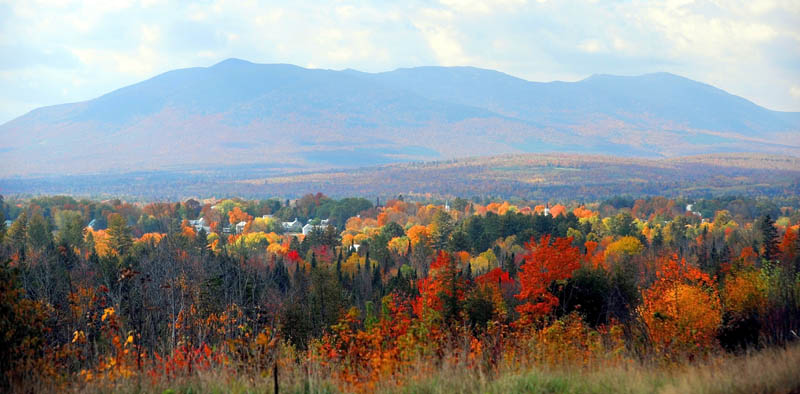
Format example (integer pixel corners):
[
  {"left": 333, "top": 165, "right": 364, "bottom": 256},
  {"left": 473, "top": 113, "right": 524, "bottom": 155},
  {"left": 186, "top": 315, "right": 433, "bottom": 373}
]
[{"left": 74, "top": 344, "right": 800, "bottom": 394}]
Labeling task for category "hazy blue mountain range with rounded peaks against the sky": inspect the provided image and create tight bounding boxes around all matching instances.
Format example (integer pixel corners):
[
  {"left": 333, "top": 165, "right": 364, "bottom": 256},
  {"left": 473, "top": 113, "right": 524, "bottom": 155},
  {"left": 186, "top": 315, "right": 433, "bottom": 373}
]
[{"left": 0, "top": 59, "right": 800, "bottom": 176}]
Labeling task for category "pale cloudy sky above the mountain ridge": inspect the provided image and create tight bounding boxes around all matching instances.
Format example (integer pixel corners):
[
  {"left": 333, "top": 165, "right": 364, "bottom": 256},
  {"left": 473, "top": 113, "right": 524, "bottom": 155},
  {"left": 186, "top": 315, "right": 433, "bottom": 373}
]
[{"left": 0, "top": 0, "right": 800, "bottom": 122}]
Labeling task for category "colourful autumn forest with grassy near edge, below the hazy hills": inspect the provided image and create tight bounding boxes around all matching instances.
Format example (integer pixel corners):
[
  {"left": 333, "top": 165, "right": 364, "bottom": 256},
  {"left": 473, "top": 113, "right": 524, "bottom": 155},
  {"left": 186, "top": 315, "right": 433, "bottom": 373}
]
[{"left": 0, "top": 193, "right": 800, "bottom": 392}]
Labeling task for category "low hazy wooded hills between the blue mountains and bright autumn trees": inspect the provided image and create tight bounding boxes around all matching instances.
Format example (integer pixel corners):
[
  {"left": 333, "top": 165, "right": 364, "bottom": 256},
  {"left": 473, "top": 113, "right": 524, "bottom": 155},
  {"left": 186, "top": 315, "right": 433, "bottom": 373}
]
[{"left": 0, "top": 154, "right": 800, "bottom": 201}]
